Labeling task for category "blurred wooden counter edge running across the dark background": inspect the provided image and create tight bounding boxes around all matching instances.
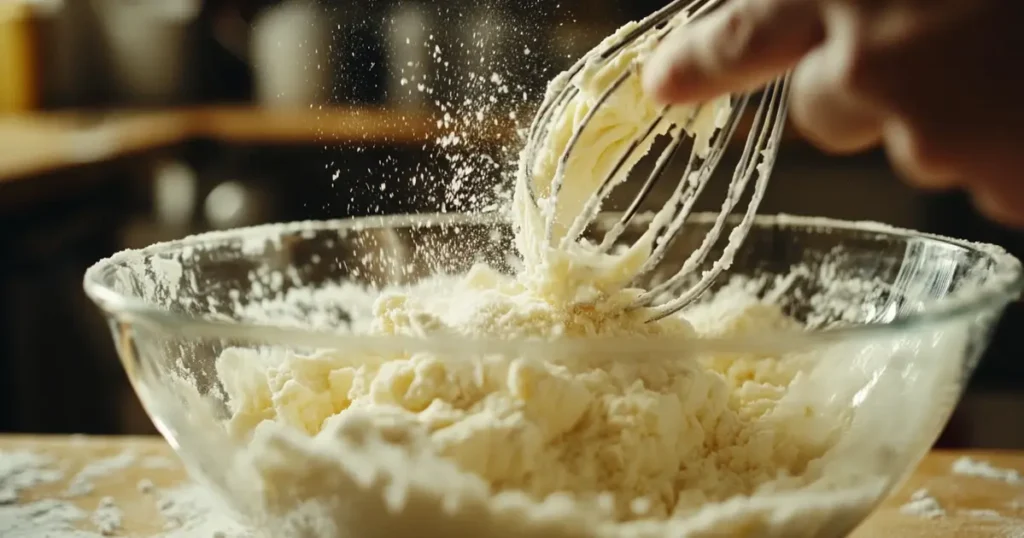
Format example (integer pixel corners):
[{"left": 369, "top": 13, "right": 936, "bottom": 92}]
[{"left": 0, "top": 107, "right": 514, "bottom": 187}]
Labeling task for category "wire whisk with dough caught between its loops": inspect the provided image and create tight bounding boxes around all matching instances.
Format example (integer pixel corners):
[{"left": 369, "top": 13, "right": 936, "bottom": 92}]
[{"left": 522, "top": 0, "right": 788, "bottom": 321}]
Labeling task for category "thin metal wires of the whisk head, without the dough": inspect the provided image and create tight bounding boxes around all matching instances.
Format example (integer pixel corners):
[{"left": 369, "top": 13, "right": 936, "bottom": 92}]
[{"left": 523, "top": 0, "right": 788, "bottom": 321}]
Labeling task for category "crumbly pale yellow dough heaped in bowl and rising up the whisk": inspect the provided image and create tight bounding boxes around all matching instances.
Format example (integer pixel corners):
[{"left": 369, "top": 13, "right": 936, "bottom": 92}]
[{"left": 193, "top": 10, "right": 950, "bottom": 538}]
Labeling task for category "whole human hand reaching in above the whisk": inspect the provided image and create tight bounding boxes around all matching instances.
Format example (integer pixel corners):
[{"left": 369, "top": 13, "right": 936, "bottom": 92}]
[{"left": 643, "top": 0, "right": 1024, "bottom": 226}]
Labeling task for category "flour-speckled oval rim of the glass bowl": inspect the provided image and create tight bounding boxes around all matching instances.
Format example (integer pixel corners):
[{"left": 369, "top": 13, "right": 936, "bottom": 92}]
[{"left": 83, "top": 212, "right": 1024, "bottom": 353}]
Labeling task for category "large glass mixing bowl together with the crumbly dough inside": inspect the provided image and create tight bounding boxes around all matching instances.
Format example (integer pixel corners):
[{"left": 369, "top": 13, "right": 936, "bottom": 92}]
[{"left": 85, "top": 215, "right": 1022, "bottom": 537}]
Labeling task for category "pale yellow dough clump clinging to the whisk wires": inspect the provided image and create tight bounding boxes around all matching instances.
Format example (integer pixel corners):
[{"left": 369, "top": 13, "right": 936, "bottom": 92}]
[{"left": 513, "top": 13, "right": 730, "bottom": 302}]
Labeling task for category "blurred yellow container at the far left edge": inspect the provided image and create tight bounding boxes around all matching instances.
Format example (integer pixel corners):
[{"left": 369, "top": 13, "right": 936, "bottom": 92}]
[{"left": 0, "top": 0, "right": 40, "bottom": 114}]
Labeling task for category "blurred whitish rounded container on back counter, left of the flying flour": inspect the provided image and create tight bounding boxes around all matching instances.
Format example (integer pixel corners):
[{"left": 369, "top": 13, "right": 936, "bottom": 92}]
[{"left": 250, "top": 0, "right": 332, "bottom": 107}]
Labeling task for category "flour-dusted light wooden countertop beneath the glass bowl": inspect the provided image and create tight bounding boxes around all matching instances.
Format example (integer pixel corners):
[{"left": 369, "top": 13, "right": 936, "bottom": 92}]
[{"left": 0, "top": 436, "right": 1024, "bottom": 538}]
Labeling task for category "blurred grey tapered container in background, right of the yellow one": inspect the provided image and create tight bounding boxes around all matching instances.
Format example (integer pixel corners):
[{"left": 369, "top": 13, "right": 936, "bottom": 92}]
[{"left": 93, "top": 0, "right": 200, "bottom": 106}]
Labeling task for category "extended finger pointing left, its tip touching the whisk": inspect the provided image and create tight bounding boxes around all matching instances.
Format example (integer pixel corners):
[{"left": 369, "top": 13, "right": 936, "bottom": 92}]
[{"left": 643, "top": 0, "right": 822, "bottom": 104}]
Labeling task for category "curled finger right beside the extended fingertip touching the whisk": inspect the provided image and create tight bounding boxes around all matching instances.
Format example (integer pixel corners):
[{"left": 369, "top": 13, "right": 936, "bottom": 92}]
[{"left": 790, "top": 41, "right": 883, "bottom": 154}]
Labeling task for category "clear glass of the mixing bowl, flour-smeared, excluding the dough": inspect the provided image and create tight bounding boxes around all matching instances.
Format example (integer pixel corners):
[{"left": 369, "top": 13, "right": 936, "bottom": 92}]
[{"left": 85, "top": 215, "right": 1022, "bottom": 537}]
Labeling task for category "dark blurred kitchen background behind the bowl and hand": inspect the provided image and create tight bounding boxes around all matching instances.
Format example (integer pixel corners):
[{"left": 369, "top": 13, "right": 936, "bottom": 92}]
[{"left": 0, "top": 0, "right": 1024, "bottom": 448}]
